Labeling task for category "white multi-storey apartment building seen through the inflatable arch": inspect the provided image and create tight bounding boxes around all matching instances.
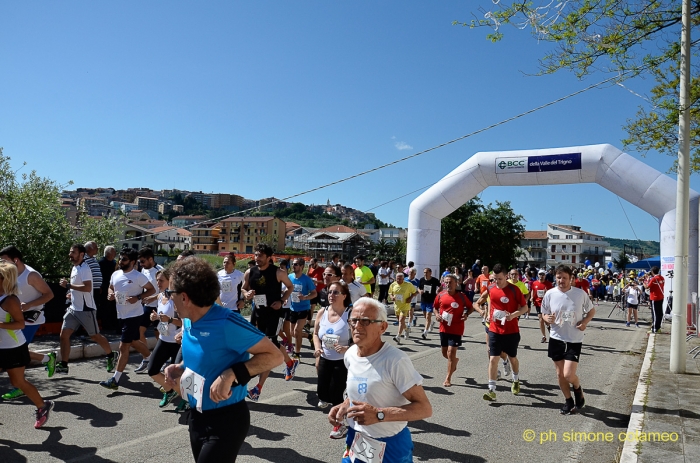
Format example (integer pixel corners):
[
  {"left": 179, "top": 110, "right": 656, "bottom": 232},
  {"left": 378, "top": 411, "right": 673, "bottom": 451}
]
[{"left": 547, "top": 224, "right": 610, "bottom": 267}]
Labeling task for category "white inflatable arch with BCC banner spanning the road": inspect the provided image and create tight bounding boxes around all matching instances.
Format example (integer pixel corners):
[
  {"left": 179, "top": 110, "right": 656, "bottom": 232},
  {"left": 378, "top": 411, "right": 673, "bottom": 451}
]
[{"left": 407, "top": 144, "right": 700, "bottom": 295}]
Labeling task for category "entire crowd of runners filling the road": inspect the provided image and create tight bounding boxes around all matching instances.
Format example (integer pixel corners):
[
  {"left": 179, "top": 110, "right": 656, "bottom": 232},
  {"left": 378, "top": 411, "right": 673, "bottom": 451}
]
[{"left": 0, "top": 242, "right": 664, "bottom": 463}]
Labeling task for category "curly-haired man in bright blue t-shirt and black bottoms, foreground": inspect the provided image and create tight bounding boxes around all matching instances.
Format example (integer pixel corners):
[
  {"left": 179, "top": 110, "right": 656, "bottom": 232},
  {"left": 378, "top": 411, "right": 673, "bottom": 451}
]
[{"left": 165, "top": 258, "right": 282, "bottom": 463}]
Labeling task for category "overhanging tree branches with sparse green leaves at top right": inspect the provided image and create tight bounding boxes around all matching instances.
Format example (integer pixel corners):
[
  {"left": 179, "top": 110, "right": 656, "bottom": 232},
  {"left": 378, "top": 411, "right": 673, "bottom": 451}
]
[{"left": 462, "top": 0, "right": 700, "bottom": 172}]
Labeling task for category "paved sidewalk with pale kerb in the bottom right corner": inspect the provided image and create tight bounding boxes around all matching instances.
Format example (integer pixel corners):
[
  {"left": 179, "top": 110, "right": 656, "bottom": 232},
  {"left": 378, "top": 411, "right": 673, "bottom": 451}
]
[{"left": 620, "top": 325, "right": 700, "bottom": 463}]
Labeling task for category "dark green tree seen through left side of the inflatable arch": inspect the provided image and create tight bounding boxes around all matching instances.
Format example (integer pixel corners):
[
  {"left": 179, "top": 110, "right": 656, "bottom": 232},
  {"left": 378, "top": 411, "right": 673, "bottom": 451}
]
[{"left": 440, "top": 198, "right": 525, "bottom": 271}]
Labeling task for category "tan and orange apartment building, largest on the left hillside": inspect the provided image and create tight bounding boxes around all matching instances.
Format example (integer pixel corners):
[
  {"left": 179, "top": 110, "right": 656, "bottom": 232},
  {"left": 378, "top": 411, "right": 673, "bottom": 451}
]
[{"left": 217, "top": 217, "right": 286, "bottom": 254}]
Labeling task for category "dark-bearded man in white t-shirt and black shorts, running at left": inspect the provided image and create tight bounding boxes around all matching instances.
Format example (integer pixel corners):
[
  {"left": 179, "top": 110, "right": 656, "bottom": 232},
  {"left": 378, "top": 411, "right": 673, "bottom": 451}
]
[{"left": 100, "top": 248, "right": 156, "bottom": 391}]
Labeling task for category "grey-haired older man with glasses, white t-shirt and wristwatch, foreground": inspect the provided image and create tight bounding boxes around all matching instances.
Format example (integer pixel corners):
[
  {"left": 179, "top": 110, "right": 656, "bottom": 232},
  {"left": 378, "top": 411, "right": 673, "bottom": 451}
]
[{"left": 328, "top": 297, "right": 433, "bottom": 456}]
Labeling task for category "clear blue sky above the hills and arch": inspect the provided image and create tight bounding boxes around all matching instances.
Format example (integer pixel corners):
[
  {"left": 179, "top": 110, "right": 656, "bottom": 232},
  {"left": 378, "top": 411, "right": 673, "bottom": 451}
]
[{"left": 0, "top": 0, "right": 700, "bottom": 240}]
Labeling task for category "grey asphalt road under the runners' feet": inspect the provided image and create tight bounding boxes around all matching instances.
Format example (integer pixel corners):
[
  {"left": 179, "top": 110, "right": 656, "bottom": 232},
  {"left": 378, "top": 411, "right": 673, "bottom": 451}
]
[{"left": 0, "top": 304, "right": 648, "bottom": 463}]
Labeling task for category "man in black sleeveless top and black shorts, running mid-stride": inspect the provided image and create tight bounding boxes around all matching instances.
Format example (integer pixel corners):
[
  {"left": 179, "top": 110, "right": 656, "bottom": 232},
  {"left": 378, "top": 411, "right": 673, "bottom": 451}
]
[{"left": 242, "top": 243, "right": 299, "bottom": 402}]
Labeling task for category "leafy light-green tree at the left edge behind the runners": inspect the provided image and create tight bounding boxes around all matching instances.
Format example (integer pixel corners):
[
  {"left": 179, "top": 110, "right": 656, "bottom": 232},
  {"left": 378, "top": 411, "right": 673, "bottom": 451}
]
[{"left": 0, "top": 148, "right": 74, "bottom": 281}]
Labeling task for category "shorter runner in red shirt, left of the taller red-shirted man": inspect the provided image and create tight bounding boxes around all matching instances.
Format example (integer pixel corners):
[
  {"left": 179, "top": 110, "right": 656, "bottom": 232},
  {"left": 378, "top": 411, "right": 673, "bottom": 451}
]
[{"left": 433, "top": 274, "right": 474, "bottom": 387}]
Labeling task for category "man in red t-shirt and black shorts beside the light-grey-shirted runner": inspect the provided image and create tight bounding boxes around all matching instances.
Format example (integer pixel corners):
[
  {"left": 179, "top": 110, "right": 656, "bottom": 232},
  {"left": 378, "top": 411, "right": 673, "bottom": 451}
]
[{"left": 484, "top": 264, "right": 527, "bottom": 401}]
